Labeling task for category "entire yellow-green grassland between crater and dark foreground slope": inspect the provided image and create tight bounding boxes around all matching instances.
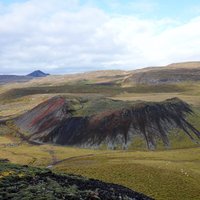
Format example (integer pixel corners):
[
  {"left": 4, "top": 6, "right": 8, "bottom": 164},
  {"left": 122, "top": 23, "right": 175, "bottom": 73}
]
[{"left": 0, "top": 136, "right": 200, "bottom": 200}]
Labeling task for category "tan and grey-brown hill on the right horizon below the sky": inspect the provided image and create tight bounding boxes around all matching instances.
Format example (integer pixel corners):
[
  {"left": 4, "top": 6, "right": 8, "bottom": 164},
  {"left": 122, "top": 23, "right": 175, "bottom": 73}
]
[{"left": 124, "top": 62, "right": 200, "bottom": 84}]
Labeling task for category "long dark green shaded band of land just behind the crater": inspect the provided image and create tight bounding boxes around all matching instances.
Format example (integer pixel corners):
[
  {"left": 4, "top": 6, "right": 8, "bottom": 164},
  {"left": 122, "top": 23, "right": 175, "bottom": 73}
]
[{"left": 0, "top": 83, "right": 185, "bottom": 102}]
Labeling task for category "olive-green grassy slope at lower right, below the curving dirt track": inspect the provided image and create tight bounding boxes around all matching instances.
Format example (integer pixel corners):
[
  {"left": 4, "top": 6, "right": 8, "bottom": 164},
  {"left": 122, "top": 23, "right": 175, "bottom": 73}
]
[{"left": 55, "top": 148, "right": 200, "bottom": 200}]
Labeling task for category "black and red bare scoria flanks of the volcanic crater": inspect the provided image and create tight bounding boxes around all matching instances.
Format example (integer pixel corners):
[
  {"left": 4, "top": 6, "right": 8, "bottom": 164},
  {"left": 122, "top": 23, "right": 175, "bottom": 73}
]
[{"left": 16, "top": 97, "right": 200, "bottom": 149}]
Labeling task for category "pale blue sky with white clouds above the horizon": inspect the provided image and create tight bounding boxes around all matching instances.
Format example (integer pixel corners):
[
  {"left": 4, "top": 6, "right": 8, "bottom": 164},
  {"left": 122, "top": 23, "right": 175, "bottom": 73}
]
[{"left": 0, "top": 0, "right": 200, "bottom": 74}]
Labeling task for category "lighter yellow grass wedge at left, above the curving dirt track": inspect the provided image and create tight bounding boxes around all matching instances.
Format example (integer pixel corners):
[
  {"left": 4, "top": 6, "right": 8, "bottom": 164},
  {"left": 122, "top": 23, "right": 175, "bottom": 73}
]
[{"left": 0, "top": 136, "right": 108, "bottom": 167}]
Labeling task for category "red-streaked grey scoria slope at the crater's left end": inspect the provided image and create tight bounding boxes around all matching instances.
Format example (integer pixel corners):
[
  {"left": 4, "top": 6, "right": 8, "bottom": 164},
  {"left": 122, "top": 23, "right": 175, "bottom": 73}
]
[{"left": 15, "top": 96, "right": 71, "bottom": 138}]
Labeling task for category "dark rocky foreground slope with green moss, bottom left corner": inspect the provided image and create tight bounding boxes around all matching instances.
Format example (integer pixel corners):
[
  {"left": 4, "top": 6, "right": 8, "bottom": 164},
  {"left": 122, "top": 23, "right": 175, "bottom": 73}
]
[{"left": 0, "top": 163, "right": 152, "bottom": 200}]
